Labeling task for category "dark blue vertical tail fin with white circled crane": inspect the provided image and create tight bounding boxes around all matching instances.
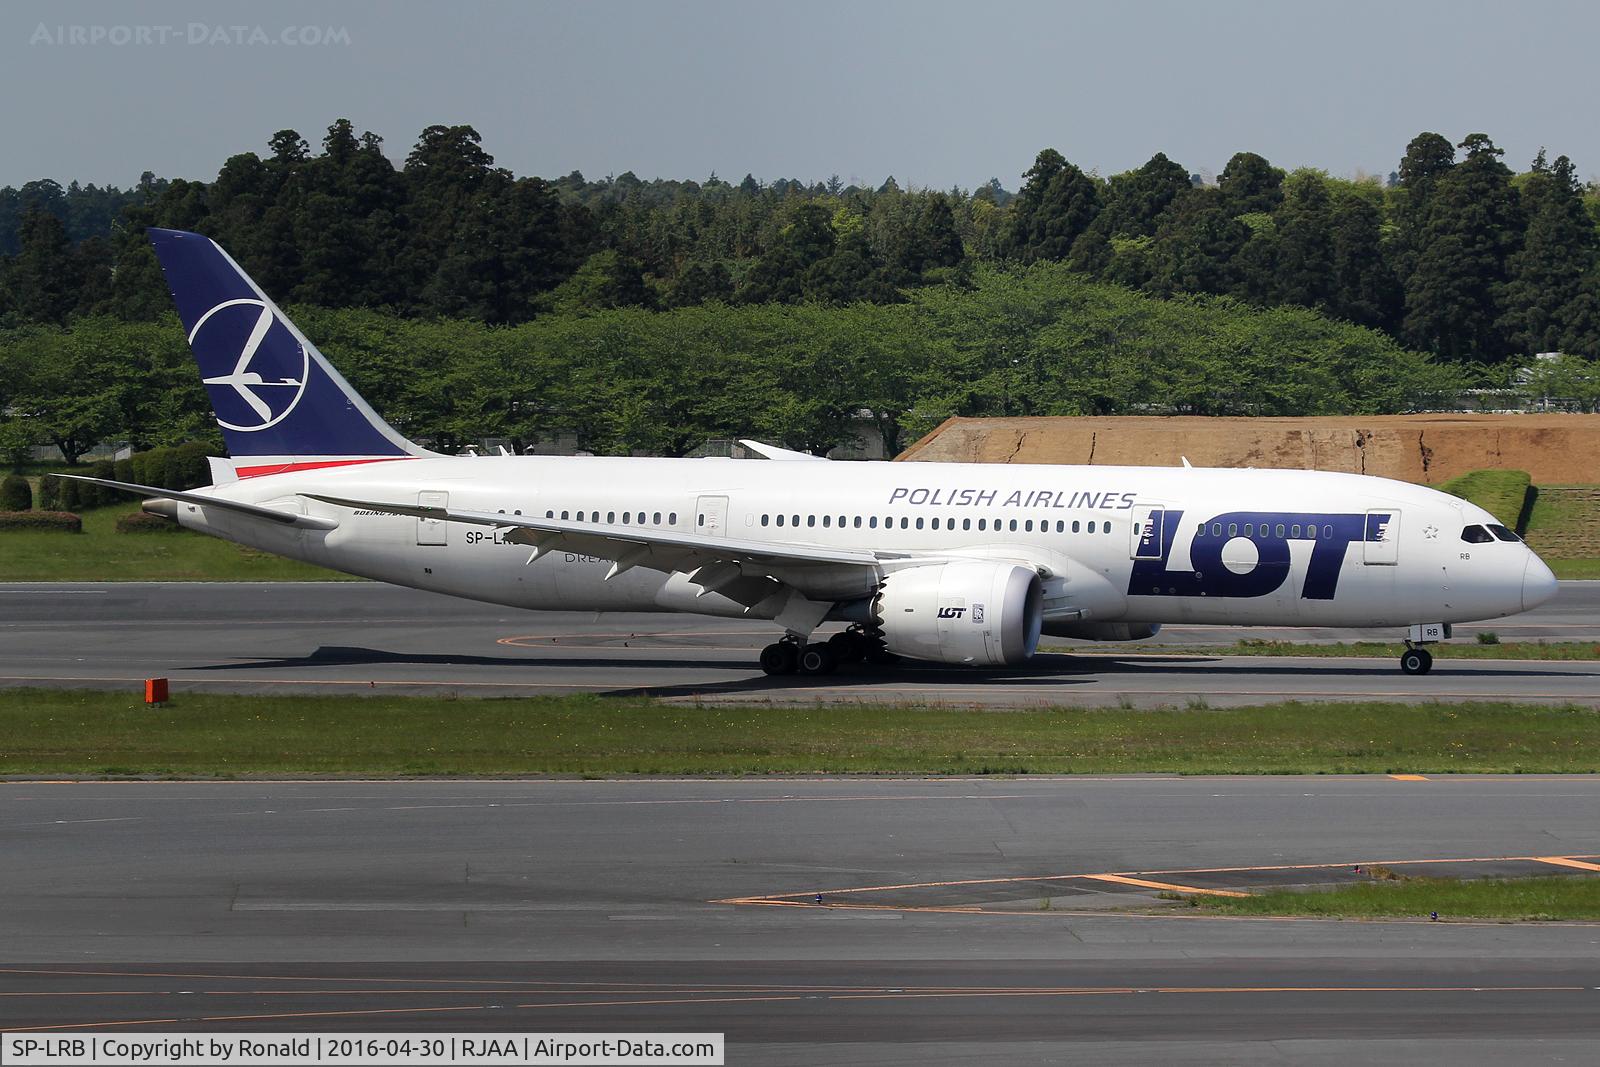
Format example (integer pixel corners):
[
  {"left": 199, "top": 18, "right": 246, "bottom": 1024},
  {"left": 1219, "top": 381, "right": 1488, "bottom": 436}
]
[{"left": 149, "top": 229, "right": 432, "bottom": 477}]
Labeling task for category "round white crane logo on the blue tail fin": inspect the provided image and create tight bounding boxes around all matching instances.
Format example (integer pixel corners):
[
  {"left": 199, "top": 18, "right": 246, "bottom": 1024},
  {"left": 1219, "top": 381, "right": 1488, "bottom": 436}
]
[{"left": 189, "top": 299, "right": 310, "bottom": 434}]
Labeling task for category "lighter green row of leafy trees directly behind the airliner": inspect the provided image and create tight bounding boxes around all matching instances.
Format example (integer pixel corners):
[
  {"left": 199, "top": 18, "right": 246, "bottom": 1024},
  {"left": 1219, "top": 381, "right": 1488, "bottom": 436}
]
[{"left": 0, "top": 262, "right": 1472, "bottom": 459}]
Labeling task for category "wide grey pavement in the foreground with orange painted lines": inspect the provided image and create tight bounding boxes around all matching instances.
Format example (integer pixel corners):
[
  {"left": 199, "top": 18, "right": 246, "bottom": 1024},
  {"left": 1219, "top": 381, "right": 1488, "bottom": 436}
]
[{"left": 0, "top": 776, "right": 1600, "bottom": 1064}]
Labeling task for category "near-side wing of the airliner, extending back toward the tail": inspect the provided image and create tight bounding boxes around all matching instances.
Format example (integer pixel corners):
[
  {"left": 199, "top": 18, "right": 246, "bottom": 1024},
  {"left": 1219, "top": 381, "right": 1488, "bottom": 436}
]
[{"left": 301, "top": 493, "right": 907, "bottom": 605}]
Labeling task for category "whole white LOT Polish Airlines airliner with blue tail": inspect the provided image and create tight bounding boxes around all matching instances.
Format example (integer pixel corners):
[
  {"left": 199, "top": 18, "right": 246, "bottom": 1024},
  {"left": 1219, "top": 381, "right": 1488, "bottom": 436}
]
[{"left": 59, "top": 230, "right": 1557, "bottom": 673}]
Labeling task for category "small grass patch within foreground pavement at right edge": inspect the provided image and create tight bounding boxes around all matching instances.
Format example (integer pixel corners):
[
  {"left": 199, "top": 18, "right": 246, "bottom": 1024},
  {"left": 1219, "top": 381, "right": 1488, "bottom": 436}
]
[{"left": 1186, "top": 875, "right": 1600, "bottom": 921}]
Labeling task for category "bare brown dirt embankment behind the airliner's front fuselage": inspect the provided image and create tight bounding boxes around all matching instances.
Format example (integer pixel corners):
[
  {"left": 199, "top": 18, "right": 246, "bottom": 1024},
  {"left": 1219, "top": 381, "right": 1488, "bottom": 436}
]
[{"left": 899, "top": 414, "right": 1600, "bottom": 485}]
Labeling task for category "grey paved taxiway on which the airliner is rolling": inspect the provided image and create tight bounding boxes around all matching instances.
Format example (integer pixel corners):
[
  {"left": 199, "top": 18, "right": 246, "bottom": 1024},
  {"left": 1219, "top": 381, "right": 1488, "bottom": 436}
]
[{"left": 0, "top": 582, "right": 1600, "bottom": 705}]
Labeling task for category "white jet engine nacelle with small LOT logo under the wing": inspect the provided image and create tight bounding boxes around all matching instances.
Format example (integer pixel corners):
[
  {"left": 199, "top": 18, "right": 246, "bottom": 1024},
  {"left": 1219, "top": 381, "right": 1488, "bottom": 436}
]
[{"left": 872, "top": 560, "right": 1043, "bottom": 667}]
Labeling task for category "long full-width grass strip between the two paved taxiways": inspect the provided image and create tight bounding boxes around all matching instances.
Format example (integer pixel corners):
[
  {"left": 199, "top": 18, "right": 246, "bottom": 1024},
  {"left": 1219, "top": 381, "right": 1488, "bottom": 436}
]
[{"left": 0, "top": 689, "right": 1600, "bottom": 777}]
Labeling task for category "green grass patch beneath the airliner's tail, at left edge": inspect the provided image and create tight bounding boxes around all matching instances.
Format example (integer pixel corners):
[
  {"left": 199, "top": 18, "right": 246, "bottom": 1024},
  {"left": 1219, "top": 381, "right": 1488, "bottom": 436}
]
[{"left": 0, "top": 502, "right": 355, "bottom": 582}]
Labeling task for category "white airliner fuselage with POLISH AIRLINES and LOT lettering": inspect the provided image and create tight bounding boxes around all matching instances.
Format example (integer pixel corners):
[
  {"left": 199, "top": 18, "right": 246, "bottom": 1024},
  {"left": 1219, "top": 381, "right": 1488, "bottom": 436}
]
[{"left": 168, "top": 456, "right": 1554, "bottom": 632}]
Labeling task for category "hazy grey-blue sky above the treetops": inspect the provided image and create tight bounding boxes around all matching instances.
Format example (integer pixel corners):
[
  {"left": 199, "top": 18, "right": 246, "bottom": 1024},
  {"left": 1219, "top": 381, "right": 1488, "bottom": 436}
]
[{"left": 0, "top": 0, "right": 1600, "bottom": 189}]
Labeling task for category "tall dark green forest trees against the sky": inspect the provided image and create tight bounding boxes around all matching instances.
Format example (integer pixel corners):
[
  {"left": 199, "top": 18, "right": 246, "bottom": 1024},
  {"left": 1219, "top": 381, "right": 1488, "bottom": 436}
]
[{"left": 0, "top": 120, "right": 1600, "bottom": 365}]
